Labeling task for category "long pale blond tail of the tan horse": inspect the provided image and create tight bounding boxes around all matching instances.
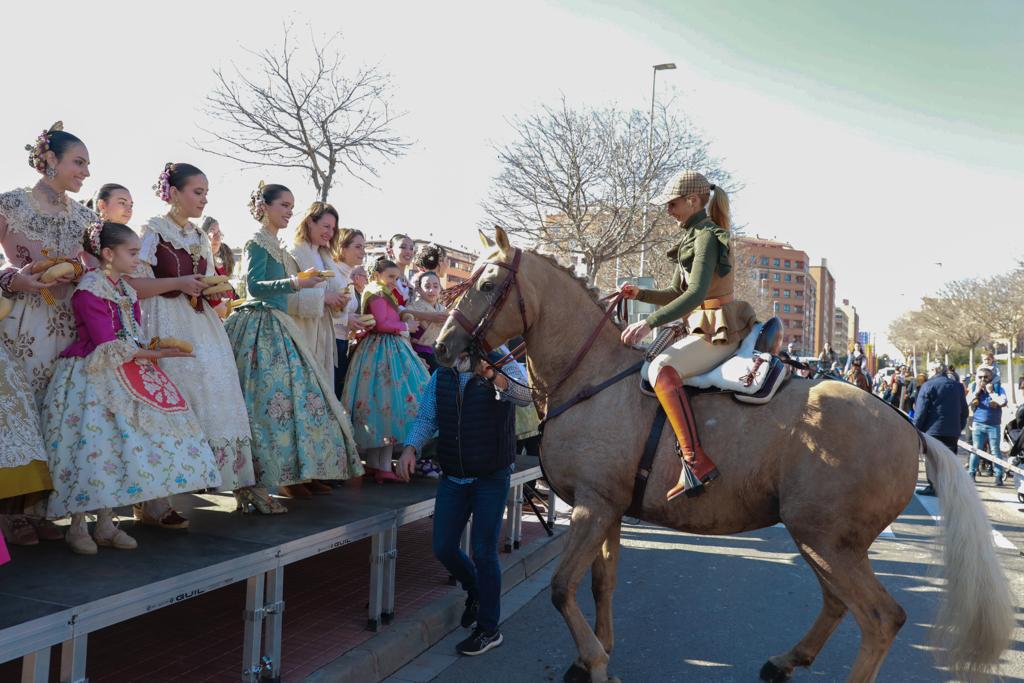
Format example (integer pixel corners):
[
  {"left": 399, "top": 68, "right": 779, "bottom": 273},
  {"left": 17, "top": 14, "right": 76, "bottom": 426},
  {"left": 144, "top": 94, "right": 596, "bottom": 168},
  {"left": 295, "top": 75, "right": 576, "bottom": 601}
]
[{"left": 924, "top": 434, "right": 1015, "bottom": 680}]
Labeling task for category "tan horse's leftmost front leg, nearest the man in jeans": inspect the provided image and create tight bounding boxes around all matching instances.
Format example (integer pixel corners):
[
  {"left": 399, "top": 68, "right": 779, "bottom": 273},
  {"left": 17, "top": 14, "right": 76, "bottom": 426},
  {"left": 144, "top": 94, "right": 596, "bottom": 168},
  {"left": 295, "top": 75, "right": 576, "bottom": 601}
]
[{"left": 551, "top": 501, "right": 621, "bottom": 683}]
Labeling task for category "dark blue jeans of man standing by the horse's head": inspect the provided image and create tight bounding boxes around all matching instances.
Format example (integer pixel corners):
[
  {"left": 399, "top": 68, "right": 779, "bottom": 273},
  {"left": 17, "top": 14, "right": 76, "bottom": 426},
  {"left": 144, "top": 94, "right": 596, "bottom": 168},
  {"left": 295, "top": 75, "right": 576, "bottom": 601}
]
[{"left": 433, "top": 468, "right": 511, "bottom": 633}]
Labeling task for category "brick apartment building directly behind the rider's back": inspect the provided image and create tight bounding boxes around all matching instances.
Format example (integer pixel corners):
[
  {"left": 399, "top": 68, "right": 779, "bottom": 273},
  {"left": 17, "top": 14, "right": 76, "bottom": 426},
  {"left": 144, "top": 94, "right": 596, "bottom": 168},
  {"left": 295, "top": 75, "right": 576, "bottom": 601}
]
[{"left": 733, "top": 237, "right": 819, "bottom": 355}]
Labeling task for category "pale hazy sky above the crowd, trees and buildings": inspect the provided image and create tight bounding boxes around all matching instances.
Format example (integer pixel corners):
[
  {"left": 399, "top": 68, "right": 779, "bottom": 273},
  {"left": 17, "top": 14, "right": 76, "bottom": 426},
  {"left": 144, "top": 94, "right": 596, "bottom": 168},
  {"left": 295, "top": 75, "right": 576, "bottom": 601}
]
[{"left": 0, "top": 0, "right": 1024, "bottom": 352}]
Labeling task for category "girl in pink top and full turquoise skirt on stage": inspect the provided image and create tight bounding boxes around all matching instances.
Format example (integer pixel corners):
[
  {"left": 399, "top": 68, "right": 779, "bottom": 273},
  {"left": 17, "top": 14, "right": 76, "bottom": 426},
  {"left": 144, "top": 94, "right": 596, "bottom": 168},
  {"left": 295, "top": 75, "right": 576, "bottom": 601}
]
[{"left": 342, "top": 258, "right": 429, "bottom": 482}]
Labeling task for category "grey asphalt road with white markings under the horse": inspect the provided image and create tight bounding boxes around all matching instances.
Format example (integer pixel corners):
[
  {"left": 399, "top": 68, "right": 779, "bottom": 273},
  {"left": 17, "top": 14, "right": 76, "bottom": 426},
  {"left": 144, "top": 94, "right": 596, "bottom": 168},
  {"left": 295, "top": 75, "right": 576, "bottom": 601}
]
[{"left": 389, "top": 464, "right": 1024, "bottom": 683}]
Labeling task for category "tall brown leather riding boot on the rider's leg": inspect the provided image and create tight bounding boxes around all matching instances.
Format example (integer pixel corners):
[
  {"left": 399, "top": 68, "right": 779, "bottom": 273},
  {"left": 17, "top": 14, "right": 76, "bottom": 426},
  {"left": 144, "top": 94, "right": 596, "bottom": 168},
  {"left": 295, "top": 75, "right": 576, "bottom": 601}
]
[{"left": 654, "top": 367, "right": 718, "bottom": 501}]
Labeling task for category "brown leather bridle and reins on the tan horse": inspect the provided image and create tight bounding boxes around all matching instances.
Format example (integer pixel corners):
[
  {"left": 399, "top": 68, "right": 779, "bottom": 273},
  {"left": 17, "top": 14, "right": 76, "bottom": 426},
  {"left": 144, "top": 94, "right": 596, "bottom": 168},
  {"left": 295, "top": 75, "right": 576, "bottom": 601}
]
[{"left": 444, "top": 248, "right": 626, "bottom": 399}]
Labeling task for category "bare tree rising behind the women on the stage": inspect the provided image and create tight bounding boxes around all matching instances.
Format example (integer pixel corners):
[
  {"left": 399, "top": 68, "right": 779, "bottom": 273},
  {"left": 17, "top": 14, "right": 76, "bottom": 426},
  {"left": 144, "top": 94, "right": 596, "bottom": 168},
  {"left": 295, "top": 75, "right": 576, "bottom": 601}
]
[{"left": 194, "top": 25, "right": 409, "bottom": 201}]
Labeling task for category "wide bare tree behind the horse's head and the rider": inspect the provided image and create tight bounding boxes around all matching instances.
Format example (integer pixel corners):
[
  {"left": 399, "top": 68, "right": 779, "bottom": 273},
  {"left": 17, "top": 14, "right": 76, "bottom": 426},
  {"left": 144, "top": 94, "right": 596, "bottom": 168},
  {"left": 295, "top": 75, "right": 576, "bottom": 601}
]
[{"left": 483, "top": 98, "right": 730, "bottom": 284}]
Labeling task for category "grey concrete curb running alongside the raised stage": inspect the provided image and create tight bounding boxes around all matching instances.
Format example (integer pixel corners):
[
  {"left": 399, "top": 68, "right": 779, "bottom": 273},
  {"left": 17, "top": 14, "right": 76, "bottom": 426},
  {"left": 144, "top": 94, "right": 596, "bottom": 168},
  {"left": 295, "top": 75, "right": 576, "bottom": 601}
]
[{"left": 305, "top": 526, "right": 567, "bottom": 683}]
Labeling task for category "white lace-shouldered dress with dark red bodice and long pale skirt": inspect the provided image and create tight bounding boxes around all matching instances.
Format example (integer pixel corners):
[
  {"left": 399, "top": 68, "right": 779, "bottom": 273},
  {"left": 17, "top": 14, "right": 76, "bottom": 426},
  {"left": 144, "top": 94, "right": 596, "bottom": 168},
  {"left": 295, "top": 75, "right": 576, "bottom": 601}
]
[{"left": 136, "top": 216, "right": 256, "bottom": 490}]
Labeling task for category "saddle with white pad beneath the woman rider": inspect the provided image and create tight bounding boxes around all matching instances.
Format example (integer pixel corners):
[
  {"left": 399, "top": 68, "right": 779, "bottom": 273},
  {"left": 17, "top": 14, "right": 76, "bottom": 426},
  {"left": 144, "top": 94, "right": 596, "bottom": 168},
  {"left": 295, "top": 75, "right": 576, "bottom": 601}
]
[{"left": 640, "top": 317, "right": 792, "bottom": 404}]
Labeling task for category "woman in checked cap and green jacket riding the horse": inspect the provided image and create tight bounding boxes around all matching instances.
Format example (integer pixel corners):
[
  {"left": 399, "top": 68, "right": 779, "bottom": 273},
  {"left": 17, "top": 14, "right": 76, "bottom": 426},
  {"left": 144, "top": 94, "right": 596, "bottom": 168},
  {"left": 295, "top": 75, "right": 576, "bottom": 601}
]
[{"left": 620, "top": 171, "right": 756, "bottom": 501}]
